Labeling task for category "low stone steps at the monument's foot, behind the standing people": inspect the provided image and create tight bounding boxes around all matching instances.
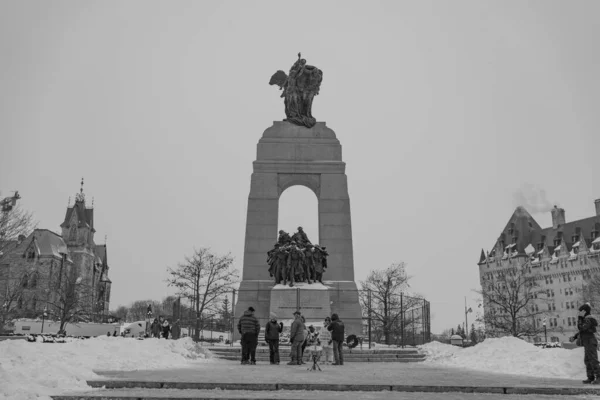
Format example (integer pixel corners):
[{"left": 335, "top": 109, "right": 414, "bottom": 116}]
[{"left": 209, "top": 346, "right": 425, "bottom": 363}]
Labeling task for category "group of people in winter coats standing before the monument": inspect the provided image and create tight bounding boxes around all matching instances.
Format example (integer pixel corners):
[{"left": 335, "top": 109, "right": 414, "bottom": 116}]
[{"left": 237, "top": 307, "right": 345, "bottom": 365}]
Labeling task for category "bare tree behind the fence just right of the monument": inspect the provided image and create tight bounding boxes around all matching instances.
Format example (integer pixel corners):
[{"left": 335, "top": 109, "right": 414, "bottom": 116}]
[{"left": 359, "top": 262, "right": 422, "bottom": 344}]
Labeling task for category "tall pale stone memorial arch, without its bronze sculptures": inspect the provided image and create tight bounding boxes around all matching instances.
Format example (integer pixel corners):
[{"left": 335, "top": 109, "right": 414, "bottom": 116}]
[{"left": 235, "top": 121, "right": 362, "bottom": 334}]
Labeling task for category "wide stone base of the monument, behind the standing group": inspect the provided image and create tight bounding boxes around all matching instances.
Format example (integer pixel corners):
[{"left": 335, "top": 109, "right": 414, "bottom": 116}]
[{"left": 234, "top": 280, "right": 363, "bottom": 340}]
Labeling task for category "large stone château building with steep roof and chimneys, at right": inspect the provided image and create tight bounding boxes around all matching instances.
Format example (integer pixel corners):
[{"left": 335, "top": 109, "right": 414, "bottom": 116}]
[{"left": 478, "top": 199, "right": 600, "bottom": 342}]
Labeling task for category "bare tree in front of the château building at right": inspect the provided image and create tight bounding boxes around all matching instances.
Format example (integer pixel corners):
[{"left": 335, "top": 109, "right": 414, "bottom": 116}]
[{"left": 476, "top": 262, "right": 550, "bottom": 337}]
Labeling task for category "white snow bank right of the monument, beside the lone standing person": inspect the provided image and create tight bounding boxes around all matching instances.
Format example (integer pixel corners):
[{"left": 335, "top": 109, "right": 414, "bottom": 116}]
[{"left": 419, "top": 337, "right": 586, "bottom": 379}]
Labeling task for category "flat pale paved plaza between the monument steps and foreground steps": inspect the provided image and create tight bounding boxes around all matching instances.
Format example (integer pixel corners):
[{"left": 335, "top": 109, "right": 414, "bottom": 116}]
[{"left": 96, "top": 360, "right": 584, "bottom": 389}]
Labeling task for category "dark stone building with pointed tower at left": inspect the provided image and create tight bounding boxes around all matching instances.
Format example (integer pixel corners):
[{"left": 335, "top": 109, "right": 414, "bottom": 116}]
[{"left": 0, "top": 182, "right": 111, "bottom": 321}]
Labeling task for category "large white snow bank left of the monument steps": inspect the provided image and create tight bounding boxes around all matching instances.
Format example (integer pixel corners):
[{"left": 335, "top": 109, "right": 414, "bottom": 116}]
[{"left": 0, "top": 336, "right": 211, "bottom": 400}]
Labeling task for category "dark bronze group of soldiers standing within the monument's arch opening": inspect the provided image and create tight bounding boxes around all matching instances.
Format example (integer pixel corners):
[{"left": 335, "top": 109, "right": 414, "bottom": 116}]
[{"left": 267, "top": 226, "right": 329, "bottom": 287}]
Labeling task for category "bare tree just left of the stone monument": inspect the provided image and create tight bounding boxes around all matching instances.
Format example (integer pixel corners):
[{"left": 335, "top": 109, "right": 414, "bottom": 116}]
[{"left": 167, "top": 248, "right": 237, "bottom": 341}]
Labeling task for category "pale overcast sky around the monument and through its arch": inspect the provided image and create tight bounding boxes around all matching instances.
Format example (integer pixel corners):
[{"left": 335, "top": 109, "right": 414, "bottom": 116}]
[{"left": 0, "top": 0, "right": 600, "bottom": 332}]
